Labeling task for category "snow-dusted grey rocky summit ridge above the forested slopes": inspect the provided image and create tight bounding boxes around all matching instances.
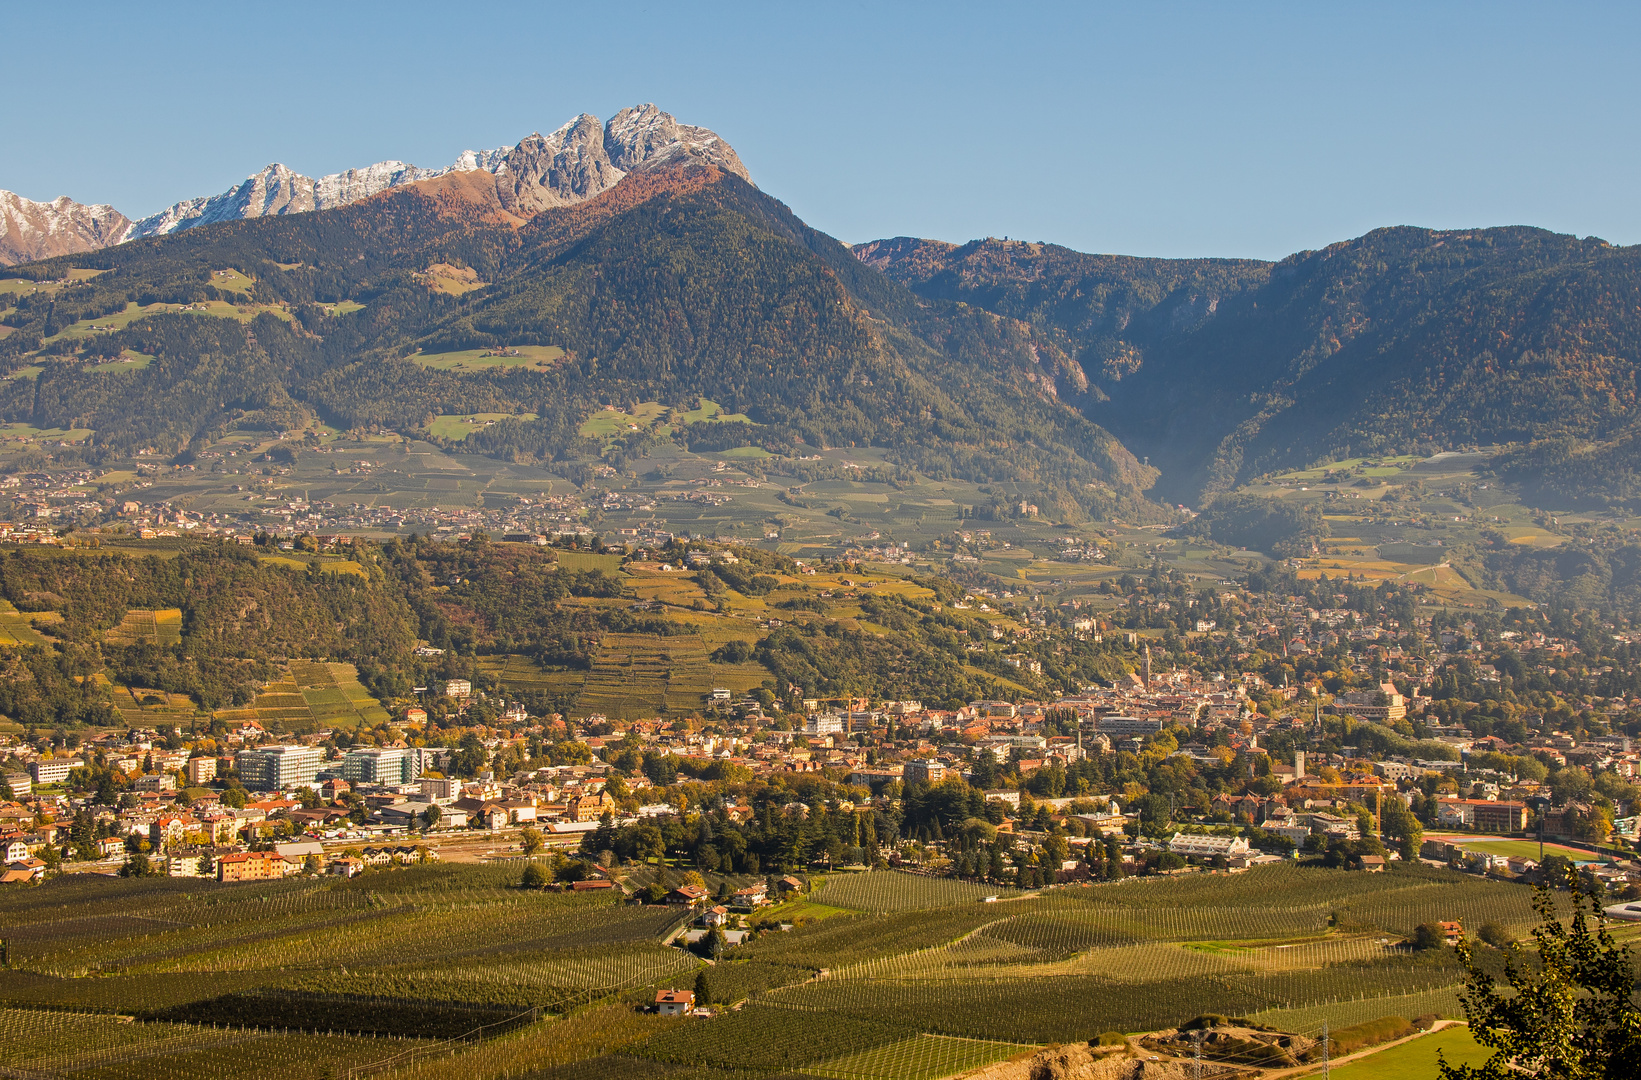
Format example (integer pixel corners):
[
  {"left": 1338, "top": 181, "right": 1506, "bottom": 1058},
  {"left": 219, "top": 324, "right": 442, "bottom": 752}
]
[{"left": 0, "top": 105, "right": 748, "bottom": 266}]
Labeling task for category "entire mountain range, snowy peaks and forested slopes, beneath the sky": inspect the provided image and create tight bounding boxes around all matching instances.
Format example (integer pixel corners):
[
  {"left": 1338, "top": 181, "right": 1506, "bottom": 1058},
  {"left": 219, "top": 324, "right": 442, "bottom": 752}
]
[{"left": 0, "top": 105, "right": 1641, "bottom": 519}]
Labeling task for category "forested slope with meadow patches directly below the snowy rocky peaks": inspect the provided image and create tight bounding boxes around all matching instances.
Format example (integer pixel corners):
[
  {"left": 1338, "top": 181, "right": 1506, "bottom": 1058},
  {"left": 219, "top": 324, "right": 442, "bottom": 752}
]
[{"left": 0, "top": 166, "right": 1154, "bottom": 515}]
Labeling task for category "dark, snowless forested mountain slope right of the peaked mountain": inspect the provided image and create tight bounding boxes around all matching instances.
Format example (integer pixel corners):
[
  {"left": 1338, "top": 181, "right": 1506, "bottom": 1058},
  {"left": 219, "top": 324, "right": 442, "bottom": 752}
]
[{"left": 857, "top": 228, "right": 1641, "bottom": 499}]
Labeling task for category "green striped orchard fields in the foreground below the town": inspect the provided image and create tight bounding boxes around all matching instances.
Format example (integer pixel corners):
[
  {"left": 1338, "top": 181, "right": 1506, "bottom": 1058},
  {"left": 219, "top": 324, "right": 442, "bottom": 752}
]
[{"left": 0, "top": 860, "right": 1533, "bottom": 1080}]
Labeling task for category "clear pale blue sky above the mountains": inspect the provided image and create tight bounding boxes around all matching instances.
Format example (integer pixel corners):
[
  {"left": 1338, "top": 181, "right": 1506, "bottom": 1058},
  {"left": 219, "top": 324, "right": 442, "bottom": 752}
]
[{"left": 0, "top": 0, "right": 1641, "bottom": 258}]
